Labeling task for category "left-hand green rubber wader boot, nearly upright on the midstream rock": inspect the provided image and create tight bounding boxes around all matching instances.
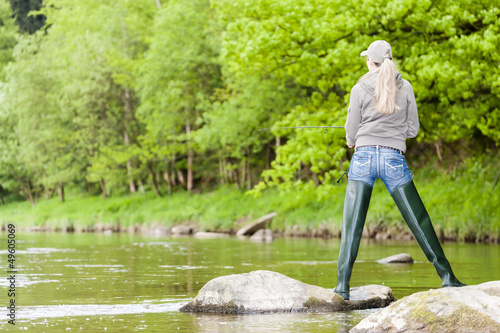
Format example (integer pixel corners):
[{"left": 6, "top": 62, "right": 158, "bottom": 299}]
[{"left": 334, "top": 180, "right": 373, "bottom": 299}]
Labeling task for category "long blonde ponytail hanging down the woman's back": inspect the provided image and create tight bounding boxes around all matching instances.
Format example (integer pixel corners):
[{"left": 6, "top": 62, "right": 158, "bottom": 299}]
[{"left": 375, "top": 54, "right": 399, "bottom": 114}]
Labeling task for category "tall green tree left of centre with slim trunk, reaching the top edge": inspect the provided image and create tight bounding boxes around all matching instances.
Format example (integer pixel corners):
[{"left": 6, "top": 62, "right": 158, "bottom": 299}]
[{"left": 138, "top": 0, "right": 221, "bottom": 191}]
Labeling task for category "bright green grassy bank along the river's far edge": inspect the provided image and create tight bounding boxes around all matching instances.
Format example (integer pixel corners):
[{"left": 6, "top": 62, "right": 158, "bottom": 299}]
[{"left": 0, "top": 162, "right": 500, "bottom": 242}]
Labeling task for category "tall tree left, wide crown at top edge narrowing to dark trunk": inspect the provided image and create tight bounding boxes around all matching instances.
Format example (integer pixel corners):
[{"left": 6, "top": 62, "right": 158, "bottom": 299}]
[{"left": 40, "top": 0, "right": 156, "bottom": 196}]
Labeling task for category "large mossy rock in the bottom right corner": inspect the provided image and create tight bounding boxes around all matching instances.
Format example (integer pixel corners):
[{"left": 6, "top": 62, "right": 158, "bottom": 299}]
[{"left": 350, "top": 281, "right": 500, "bottom": 333}]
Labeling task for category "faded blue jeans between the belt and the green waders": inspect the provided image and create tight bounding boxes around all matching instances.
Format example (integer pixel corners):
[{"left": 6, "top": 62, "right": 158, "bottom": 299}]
[{"left": 348, "top": 147, "right": 412, "bottom": 194}]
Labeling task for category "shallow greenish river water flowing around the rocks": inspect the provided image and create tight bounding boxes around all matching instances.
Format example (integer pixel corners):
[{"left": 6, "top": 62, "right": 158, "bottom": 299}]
[{"left": 0, "top": 232, "right": 500, "bottom": 332}]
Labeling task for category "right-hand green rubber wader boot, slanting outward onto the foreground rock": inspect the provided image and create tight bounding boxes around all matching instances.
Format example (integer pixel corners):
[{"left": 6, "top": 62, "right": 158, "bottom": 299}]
[{"left": 391, "top": 181, "right": 466, "bottom": 287}]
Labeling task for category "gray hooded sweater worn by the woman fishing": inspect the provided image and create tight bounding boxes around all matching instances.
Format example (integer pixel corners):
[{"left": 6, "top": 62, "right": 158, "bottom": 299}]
[{"left": 345, "top": 73, "right": 419, "bottom": 152}]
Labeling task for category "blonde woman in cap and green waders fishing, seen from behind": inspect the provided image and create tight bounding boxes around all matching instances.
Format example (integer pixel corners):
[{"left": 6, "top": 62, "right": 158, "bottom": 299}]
[{"left": 335, "top": 40, "right": 465, "bottom": 299}]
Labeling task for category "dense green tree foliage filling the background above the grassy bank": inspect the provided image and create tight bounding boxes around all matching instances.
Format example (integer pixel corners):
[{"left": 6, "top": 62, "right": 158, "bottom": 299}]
[{"left": 0, "top": 0, "right": 500, "bottom": 205}]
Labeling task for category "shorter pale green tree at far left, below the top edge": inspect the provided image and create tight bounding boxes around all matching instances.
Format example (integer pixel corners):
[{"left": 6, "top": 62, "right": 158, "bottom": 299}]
[{"left": 5, "top": 34, "right": 80, "bottom": 201}]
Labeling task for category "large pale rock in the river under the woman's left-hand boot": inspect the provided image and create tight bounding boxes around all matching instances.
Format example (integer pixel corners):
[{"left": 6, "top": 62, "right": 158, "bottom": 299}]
[{"left": 180, "top": 270, "right": 394, "bottom": 314}]
